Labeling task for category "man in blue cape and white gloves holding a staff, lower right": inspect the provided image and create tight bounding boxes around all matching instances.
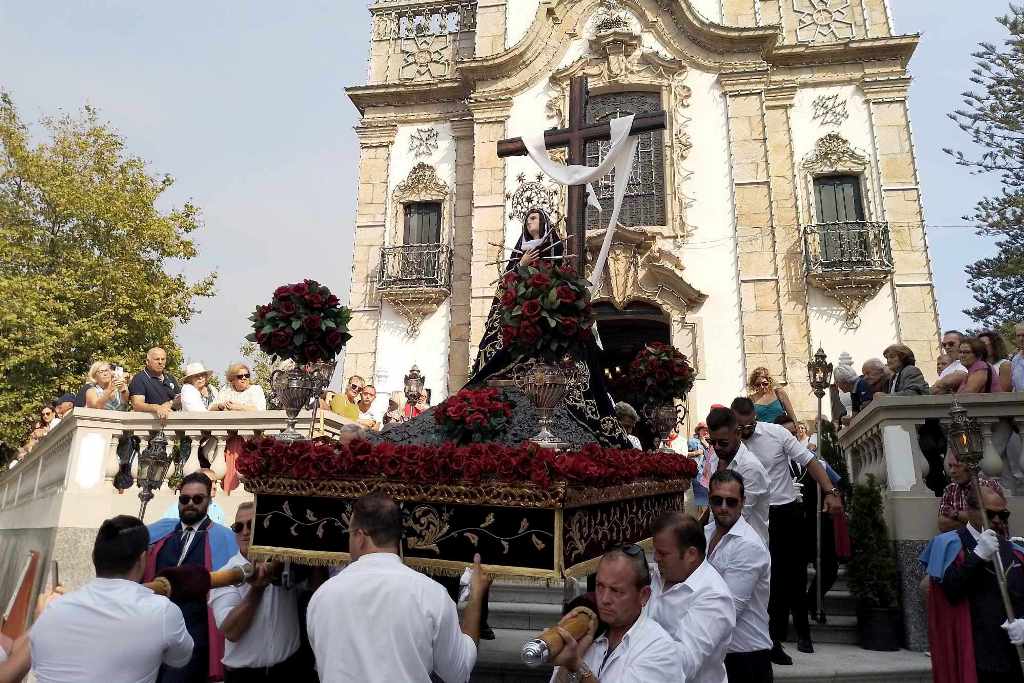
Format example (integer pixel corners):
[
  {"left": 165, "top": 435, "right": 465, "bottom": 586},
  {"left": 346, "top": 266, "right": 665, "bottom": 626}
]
[{"left": 920, "top": 485, "right": 1024, "bottom": 683}]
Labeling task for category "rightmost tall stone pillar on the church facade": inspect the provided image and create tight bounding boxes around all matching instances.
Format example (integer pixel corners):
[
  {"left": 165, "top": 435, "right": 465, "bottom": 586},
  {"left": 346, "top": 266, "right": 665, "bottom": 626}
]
[{"left": 863, "top": 78, "right": 939, "bottom": 381}]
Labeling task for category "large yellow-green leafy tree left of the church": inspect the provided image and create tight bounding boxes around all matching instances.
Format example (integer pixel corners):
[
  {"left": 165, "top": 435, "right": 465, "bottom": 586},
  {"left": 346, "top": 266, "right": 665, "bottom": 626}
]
[{"left": 0, "top": 92, "right": 215, "bottom": 444}]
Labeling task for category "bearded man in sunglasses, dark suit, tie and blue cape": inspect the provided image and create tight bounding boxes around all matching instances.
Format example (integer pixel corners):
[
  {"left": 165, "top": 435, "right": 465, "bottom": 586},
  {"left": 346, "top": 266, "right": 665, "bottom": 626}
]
[{"left": 145, "top": 472, "right": 239, "bottom": 683}]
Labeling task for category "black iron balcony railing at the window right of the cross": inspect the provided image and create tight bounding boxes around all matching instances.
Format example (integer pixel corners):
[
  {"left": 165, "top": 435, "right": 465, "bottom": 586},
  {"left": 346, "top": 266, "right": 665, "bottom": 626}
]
[{"left": 804, "top": 220, "right": 893, "bottom": 276}]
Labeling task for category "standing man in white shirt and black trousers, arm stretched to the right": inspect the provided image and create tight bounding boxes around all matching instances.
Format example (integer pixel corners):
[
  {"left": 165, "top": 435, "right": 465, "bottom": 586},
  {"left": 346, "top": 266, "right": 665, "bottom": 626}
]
[{"left": 732, "top": 397, "right": 843, "bottom": 666}]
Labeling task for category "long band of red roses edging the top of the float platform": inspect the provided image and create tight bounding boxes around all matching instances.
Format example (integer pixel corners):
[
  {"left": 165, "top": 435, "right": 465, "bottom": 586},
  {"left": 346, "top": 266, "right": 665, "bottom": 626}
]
[{"left": 236, "top": 436, "right": 696, "bottom": 487}]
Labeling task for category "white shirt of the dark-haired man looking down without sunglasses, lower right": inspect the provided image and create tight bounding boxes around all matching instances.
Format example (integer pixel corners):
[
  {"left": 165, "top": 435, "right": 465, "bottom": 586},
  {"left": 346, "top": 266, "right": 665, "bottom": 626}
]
[{"left": 645, "top": 561, "right": 736, "bottom": 683}]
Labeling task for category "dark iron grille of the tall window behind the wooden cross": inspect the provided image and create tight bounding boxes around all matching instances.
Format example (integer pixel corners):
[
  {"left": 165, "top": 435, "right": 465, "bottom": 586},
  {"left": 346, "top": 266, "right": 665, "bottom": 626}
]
[{"left": 587, "top": 92, "right": 665, "bottom": 229}]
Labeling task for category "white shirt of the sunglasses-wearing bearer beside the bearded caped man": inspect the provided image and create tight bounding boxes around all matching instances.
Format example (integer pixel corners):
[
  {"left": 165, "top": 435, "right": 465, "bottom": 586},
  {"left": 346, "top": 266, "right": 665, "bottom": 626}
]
[{"left": 209, "top": 553, "right": 299, "bottom": 669}]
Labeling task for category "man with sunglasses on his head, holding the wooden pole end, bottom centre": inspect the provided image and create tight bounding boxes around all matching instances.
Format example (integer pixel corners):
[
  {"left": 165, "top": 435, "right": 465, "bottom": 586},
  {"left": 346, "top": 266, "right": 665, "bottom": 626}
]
[{"left": 551, "top": 545, "right": 684, "bottom": 683}]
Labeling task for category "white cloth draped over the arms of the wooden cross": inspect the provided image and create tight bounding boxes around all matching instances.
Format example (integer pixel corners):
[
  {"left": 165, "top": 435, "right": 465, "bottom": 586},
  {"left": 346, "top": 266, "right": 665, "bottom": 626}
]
[{"left": 522, "top": 114, "right": 639, "bottom": 292}]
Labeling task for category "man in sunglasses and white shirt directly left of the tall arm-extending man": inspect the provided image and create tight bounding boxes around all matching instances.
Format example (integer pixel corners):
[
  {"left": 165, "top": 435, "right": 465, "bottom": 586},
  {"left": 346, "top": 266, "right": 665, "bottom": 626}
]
[{"left": 707, "top": 408, "right": 770, "bottom": 545}]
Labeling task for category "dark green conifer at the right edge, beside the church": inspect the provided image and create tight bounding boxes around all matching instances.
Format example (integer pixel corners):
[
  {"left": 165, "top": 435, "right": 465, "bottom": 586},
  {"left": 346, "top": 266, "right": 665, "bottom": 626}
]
[{"left": 945, "top": 5, "right": 1024, "bottom": 329}]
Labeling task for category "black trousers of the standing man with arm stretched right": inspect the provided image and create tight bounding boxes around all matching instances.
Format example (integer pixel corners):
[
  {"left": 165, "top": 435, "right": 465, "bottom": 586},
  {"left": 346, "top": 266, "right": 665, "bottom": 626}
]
[{"left": 768, "top": 501, "right": 811, "bottom": 643}]
